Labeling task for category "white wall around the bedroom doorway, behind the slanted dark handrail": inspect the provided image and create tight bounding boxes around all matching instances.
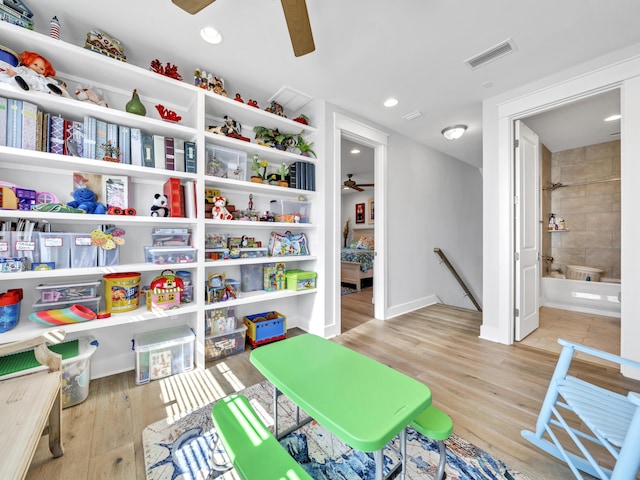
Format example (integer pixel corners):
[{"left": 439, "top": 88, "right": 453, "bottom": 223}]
[{"left": 324, "top": 104, "right": 482, "bottom": 328}]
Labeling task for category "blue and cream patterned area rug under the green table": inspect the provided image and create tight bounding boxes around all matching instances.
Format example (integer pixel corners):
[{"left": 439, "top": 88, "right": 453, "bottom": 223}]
[{"left": 142, "top": 382, "right": 527, "bottom": 480}]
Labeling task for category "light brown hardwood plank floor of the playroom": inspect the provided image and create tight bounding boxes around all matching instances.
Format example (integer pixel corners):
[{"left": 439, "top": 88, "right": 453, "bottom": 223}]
[{"left": 27, "top": 302, "right": 640, "bottom": 480}]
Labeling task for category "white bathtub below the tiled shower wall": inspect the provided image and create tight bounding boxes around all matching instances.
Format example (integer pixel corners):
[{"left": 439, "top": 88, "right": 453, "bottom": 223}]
[{"left": 540, "top": 274, "right": 620, "bottom": 318}]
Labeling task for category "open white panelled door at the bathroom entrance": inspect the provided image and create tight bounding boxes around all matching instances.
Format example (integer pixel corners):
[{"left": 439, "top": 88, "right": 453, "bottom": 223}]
[{"left": 514, "top": 120, "right": 541, "bottom": 341}]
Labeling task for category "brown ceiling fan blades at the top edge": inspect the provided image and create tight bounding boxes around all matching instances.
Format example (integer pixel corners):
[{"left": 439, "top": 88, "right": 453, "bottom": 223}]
[{"left": 171, "top": 0, "right": 316, "bottom": 57}]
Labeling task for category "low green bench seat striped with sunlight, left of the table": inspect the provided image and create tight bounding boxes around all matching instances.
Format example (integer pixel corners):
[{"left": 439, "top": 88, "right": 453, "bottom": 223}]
[{"left": 211, "top": 395, "right": 313, "bottom": 480}]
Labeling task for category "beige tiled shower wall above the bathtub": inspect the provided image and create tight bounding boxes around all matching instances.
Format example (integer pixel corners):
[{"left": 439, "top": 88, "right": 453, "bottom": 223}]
[{"left": 541, "top": 141, "right": 620, "bottom": 278}]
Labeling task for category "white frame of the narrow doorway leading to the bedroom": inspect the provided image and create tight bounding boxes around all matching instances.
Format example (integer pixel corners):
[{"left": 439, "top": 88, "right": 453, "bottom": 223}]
[{"left": 331, "top": 113, "right": 388, "bottom": 326}]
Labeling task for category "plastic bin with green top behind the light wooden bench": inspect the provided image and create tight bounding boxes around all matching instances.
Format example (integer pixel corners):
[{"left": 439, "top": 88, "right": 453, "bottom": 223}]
[{"left": 0, "top": 336, "right": 98, "bottom": 408}]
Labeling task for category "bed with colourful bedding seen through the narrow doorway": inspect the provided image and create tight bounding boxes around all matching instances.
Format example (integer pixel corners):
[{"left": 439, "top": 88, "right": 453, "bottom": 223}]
[{"left": 340, "top": 228, "right": 374, "bottom": 292}]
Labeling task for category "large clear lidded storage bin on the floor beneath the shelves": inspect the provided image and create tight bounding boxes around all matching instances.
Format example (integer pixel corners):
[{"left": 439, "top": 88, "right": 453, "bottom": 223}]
[{"left": 133, "top": 325, "right": 196, "bottom": 385}]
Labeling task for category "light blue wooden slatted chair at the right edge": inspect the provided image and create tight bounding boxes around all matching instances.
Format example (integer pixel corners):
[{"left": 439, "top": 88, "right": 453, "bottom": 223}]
[{"left": 522, "top": 339, "right": 640, "bottom": 480}]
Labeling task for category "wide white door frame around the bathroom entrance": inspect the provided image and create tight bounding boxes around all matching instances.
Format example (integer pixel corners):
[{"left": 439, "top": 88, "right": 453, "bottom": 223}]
[{"left": 480, "top": 44, "right": 640, "bottom": 378}]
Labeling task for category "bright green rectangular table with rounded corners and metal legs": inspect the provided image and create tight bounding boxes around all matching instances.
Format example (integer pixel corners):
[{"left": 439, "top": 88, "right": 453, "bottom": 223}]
[{"left": 251, "top": 334, "right": 431, "bottom": 480}]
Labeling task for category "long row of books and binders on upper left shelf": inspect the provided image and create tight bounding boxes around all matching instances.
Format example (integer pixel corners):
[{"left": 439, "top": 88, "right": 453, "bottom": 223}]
[{"left": 0, "top": 97, "right": 196, "bottom": 173}]
